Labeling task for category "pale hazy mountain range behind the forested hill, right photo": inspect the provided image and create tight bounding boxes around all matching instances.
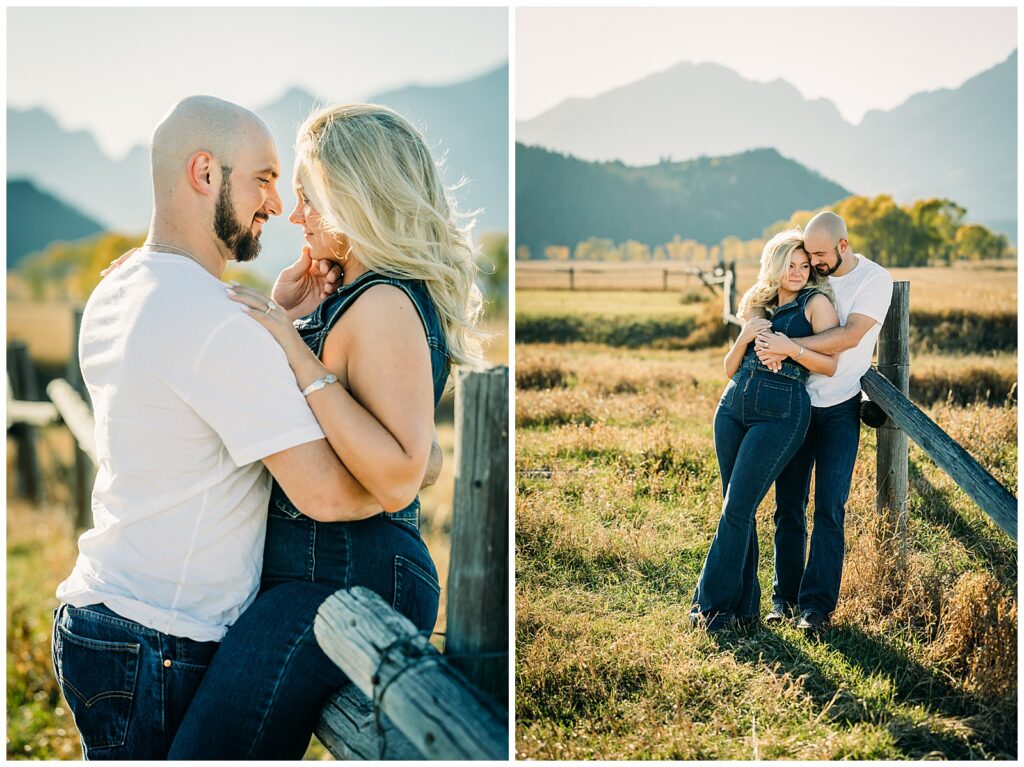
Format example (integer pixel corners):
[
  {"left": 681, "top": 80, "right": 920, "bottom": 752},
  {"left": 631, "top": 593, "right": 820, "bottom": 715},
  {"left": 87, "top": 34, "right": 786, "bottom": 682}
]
[{"left": 516, "top": 51, "right": 1017, "bottom": 240}]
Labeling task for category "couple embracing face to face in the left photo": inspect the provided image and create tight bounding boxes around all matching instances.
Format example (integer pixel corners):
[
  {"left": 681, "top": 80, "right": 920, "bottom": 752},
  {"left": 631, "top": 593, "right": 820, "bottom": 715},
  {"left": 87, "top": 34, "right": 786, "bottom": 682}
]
[{"left": 53, "top": 96, "right": 480, "bottom": 760}]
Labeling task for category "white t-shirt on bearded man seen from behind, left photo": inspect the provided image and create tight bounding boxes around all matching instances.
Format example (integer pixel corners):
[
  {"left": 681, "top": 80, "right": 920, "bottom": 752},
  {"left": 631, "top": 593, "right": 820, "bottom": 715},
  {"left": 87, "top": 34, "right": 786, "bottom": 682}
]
[{"left": 57, "top": 251, "right": 324, "bottom": 641}]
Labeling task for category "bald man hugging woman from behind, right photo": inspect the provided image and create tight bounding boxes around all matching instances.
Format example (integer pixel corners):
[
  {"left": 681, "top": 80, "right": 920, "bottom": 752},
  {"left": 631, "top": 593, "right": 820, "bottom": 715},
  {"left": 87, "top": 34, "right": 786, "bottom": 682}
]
[{"left": 755, "top": 211, "right": 893, "bottom": 632}]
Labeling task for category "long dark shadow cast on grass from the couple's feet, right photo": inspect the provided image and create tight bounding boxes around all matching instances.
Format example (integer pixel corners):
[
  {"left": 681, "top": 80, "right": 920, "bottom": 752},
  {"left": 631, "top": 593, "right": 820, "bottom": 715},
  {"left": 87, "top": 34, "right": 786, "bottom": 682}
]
[{"left": 715, "top": 626, "right": 1017, "bottom": 759}]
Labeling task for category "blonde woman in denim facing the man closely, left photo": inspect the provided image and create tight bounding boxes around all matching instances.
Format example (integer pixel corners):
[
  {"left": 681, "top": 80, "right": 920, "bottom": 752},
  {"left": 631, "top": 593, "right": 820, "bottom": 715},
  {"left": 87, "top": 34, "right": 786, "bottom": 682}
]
[{"left": 170, "top": 104, "right": 481, "bottom": 759}]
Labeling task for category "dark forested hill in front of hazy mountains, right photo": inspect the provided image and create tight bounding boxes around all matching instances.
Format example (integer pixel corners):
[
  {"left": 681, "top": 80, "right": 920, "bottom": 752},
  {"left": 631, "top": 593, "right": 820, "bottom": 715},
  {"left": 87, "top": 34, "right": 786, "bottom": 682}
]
[{"left": 515, "top": 143, "right": 850, "bottom": 250}]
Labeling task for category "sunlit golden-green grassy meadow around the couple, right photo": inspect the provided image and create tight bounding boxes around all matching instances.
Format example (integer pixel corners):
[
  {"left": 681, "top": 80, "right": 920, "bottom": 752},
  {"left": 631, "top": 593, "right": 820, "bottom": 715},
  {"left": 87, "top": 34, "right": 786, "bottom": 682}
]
[{"left": 515, "top": 264, "right": 1018, "bottom": 760}]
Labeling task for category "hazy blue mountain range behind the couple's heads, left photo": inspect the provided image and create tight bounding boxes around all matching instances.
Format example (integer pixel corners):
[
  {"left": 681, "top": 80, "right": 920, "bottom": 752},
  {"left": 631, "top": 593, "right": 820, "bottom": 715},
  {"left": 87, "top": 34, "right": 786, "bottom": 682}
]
[{"left": 7, "top": 65, "right": 509, "bottom": 275}]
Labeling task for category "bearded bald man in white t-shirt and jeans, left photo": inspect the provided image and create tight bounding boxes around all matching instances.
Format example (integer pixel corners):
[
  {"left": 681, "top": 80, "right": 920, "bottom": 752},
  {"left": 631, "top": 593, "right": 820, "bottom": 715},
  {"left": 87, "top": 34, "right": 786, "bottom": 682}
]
[{"left": 53, "top": 96, "right": 381, "bottom": 760}]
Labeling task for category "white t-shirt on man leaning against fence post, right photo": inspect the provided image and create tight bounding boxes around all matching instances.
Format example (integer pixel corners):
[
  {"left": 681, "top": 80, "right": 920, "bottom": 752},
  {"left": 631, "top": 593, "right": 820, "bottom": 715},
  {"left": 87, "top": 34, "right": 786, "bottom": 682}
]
[{"left": 807, "top": 253, "right": 893, "bottom": 408}]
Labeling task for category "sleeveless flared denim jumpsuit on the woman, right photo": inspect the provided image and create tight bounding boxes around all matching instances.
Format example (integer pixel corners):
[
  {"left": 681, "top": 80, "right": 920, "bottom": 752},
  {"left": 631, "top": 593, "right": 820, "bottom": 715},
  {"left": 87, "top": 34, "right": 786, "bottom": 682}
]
[{"left": 690, "top": 288, "right": 817, "bottom": 630}]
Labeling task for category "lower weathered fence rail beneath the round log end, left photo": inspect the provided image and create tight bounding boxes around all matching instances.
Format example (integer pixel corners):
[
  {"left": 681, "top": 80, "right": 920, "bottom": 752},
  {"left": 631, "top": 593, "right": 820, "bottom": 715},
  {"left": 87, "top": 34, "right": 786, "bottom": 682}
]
[{"left": 316, "top": 684, "right": 422, "bottom": 761}]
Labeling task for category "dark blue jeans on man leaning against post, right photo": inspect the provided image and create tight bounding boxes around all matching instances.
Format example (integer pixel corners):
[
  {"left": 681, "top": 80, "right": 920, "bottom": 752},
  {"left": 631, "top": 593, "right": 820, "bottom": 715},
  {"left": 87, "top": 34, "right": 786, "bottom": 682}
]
[{"left": 772, "top": 393, "right": 860, "bottom": 617}]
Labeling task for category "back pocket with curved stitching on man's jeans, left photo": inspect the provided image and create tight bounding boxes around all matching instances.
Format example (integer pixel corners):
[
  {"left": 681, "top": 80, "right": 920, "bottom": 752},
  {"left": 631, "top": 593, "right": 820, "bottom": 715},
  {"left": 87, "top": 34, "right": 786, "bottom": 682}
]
[{"left": 53, "top": 625, "right": 140, "bottom": 749}]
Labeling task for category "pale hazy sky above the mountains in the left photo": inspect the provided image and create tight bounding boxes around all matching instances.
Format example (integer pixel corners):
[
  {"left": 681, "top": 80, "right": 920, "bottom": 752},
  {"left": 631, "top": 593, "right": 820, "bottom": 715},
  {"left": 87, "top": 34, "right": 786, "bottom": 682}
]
[{"left": 7, "top": 7, "right": 508, "bottom": 157}]
